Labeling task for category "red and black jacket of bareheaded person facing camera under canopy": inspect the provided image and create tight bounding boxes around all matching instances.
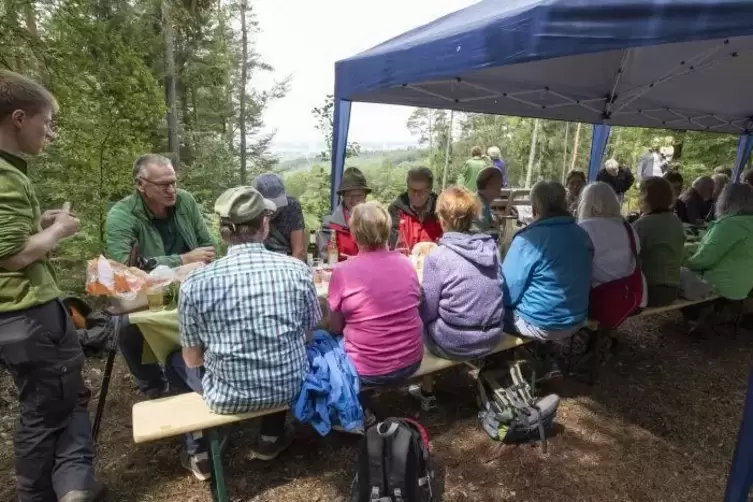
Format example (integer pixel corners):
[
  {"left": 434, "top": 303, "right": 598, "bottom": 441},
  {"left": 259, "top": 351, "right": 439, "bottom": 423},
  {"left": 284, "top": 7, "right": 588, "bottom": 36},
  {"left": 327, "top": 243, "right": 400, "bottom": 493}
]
[{"left": 389, "top": 193, "right": 442, "bottom": 251}]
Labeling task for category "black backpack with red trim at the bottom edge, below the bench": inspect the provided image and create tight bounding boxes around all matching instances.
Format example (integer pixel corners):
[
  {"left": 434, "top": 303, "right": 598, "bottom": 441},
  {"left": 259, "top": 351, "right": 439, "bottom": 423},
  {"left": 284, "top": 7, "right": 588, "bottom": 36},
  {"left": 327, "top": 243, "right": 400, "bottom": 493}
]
[{"left": 351, "top": 418, "right": 434, "bottom": 502}]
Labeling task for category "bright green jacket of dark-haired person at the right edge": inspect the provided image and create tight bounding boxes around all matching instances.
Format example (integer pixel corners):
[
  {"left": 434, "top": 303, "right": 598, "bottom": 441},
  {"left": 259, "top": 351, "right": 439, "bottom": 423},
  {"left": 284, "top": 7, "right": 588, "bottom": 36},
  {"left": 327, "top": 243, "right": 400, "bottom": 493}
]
[{"left": 686, "top": 213, "right": 753, "bottom": 300}]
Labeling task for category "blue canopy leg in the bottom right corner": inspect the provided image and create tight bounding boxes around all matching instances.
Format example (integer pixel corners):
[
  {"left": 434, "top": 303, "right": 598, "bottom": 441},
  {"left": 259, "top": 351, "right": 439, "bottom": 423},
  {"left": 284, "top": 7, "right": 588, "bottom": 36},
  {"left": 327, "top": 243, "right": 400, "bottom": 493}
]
[{"left": 724, "top": 364, "right": 753, "bottom": 502}]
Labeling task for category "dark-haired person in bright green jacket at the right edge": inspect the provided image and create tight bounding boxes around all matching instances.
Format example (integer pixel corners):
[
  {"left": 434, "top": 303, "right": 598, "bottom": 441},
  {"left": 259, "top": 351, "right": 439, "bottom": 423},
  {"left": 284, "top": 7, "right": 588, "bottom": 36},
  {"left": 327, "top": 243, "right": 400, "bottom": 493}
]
[{"left": 686, "top": 183, "right": 753, "bottom": 300}]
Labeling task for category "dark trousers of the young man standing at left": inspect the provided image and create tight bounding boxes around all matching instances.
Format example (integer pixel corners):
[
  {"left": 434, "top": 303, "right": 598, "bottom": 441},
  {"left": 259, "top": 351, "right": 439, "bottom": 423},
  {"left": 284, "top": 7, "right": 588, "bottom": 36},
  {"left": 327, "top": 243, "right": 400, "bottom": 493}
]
[{"left": 0, "top": 300, "right": 95, "bottom": 502}]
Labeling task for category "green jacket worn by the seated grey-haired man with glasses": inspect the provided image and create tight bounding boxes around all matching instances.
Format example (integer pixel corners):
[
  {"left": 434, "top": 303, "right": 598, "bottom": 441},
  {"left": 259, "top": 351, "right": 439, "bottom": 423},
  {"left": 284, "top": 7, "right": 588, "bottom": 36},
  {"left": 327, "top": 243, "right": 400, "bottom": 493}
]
[{"left": 105, "top": 190, "right": 217, "bottom": 268}]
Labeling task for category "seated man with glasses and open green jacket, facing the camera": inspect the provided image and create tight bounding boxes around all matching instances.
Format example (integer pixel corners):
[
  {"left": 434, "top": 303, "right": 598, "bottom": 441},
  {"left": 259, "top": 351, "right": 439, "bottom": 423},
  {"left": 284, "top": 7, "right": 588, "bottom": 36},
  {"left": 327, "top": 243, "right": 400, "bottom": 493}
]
[{"left": 105, "top": 154, "right": 216, "bottom": 397}]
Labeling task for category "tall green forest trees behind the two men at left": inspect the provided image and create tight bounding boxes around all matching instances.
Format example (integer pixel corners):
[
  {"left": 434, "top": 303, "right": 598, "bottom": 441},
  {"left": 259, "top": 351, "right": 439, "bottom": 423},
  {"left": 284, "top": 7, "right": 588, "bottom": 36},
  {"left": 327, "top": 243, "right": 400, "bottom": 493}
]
[{"left": 0, "top": 0, "right": 287, "bottom": 293}]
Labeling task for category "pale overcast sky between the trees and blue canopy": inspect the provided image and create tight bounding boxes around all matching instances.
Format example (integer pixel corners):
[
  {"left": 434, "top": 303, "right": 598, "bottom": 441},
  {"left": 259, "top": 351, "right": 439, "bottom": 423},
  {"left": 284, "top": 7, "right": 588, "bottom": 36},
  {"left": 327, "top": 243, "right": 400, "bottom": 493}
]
[{"left": 253, "top": 0, "right": 476, "bottom": 149}]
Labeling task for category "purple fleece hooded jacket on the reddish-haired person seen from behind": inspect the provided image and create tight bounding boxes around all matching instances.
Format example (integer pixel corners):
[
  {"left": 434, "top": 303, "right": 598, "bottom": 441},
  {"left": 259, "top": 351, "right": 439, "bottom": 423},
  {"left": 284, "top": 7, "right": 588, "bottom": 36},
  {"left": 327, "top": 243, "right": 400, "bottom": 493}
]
[{"left": 420, "top": 232, "right": 504, "bottom": 358}]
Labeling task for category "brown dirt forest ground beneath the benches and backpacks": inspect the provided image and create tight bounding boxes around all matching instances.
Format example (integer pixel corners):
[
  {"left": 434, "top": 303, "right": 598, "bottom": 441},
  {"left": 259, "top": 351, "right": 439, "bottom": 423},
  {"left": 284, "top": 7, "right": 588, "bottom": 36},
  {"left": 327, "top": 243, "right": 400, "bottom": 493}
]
[{"left": 0, "top": 314, "right": 753, "bottom": 502}]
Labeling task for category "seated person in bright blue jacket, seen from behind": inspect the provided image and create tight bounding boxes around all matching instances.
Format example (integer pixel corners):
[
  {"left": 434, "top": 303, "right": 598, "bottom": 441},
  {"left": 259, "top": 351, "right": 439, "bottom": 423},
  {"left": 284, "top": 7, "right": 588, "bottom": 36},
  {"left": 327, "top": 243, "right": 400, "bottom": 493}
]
[{"left": 499, "top": 181, "right": 593, "bottom": 341}]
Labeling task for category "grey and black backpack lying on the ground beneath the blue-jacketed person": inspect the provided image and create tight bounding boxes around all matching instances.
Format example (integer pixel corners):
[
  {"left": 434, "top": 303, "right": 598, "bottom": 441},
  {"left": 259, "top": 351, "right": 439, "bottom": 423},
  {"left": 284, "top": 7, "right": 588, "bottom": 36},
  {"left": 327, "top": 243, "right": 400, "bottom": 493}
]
[{"left": 478, "top": 362, "right": 560, "bottom": 453}]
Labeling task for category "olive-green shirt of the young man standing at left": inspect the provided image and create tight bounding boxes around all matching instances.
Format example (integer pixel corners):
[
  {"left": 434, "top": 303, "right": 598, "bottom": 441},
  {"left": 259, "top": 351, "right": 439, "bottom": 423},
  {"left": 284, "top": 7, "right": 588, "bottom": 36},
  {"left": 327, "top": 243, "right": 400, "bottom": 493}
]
[{"left": 0, "top": 157, "right": 60, "bottom": 312}]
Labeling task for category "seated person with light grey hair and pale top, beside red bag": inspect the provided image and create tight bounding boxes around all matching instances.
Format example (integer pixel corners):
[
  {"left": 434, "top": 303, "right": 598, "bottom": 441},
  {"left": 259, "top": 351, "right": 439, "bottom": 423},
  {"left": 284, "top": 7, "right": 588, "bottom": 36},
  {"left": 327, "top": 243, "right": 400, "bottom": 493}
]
[{"left": 578, "top": 181, "right": 647, "bottom": 305}]
